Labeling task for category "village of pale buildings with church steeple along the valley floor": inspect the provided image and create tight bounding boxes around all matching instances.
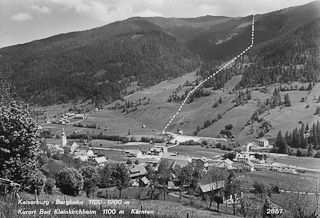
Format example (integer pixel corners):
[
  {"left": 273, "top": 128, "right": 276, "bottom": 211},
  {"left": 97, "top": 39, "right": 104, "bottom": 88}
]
[{"left": 43, "top": 124, "right": 303, "bottom": 204}]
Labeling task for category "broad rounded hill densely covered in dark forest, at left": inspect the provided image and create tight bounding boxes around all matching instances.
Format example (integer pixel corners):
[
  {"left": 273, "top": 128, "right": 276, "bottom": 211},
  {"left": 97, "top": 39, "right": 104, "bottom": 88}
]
[{"left": 0, "top": 19, "right": 196, "bottom": 105}]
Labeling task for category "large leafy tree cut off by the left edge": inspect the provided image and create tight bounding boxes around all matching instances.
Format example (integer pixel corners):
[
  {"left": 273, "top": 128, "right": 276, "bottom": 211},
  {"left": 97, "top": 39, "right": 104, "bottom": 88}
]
[{"left": 0, "top": 80, "right": 44, "bottom": 192}]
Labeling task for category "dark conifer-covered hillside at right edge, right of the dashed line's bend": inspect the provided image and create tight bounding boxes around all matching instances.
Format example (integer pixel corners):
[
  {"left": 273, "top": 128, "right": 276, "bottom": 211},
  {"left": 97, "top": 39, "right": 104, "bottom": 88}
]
[{"left": 239, "top": 19, "right": 320, "bottom": 87}]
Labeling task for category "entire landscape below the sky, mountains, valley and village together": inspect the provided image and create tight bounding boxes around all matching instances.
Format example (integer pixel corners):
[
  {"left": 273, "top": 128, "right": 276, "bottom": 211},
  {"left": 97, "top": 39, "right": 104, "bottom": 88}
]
[{"left": 0, "top": 2, "right": 320, "bottom": 218}]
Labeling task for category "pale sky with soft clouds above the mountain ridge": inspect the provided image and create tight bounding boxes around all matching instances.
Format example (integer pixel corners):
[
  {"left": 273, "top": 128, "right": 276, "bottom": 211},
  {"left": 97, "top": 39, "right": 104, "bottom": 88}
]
[{"left": 0, "top": 0, "right": 312, "bottom": 48}]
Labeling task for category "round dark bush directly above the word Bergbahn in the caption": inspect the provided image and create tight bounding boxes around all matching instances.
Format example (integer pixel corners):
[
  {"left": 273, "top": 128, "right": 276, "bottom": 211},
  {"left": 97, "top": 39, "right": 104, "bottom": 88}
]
[{"left": 56, "top": 168, "right": 83, "bottom": 196}]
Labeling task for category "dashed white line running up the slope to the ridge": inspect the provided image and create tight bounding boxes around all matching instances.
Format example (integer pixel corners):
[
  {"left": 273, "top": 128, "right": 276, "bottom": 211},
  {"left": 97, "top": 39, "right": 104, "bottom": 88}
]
[{"left": 162, "top": 15, "right": 254, "bottom": 133}]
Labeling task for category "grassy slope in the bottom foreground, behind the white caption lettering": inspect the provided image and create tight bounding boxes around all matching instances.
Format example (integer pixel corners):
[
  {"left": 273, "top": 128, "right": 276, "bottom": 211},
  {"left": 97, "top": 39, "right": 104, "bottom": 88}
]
[{"left": 0, "top": 188, "right": 240, "bottom": 218}]
